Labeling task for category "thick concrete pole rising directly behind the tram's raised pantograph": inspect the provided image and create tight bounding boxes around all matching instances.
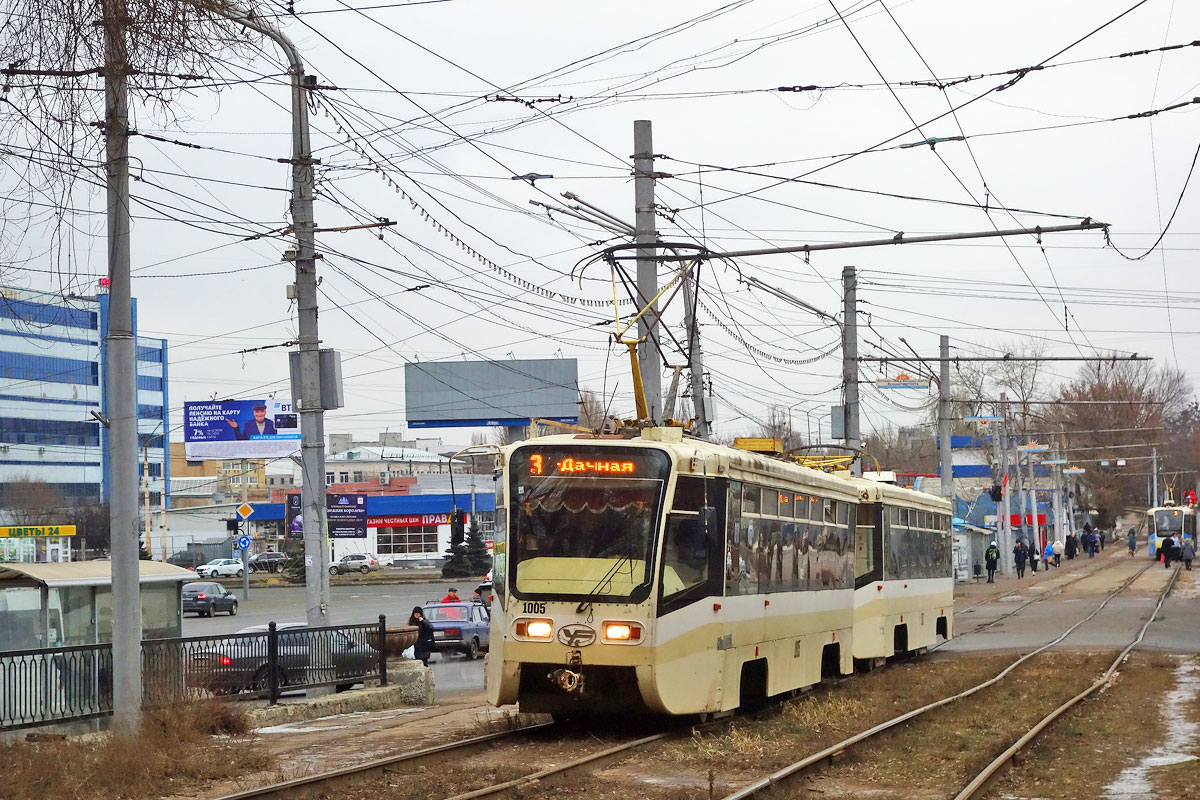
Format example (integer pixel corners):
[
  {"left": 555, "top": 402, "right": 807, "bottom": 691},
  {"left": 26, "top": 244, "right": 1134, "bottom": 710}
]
[{"left": 634, "top": 120, "right": 662, "bottom": 422}]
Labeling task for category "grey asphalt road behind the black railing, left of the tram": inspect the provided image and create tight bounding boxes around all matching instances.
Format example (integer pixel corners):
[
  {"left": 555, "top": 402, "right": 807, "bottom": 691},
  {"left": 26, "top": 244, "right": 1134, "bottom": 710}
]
[{"left": 184, "top": 579, "right": 484, "bottom": 699}]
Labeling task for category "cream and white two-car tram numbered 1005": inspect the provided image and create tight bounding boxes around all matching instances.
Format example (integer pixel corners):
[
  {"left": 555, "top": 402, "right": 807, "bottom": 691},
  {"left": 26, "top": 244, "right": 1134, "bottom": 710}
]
[{"left": 486, "top": 428, "right": 953, "bottom": 716}]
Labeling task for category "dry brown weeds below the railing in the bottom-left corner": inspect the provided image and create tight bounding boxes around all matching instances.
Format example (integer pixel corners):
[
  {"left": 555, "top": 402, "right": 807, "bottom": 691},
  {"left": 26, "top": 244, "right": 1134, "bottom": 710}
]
[{"left": 0, "top": 702, "right": 271, "bottom": 800}]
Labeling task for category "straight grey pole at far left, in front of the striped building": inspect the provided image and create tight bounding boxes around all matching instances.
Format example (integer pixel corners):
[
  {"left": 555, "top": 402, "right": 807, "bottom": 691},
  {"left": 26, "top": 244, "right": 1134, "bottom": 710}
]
[{"left": 102, "top": 0, "right": 142, "bottom": 732}]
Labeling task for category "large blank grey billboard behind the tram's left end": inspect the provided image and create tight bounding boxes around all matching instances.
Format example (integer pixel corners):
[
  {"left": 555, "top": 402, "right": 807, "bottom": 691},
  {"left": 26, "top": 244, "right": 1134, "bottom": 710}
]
[{"left": 404, "top": 359, "right": 580, "bottom": 428}]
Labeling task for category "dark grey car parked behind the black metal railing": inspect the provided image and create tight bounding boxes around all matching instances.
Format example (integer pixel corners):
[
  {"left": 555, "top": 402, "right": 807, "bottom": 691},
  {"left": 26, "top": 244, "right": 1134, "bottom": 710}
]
[{"left": 187, "top": 622, "right": 379, "bottom": 694}]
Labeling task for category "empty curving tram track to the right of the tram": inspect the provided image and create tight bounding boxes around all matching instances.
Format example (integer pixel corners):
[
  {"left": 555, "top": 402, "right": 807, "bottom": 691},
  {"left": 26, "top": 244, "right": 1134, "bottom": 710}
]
[{"left": 722, "top": 564, "right": 1161, "bottom": 800}]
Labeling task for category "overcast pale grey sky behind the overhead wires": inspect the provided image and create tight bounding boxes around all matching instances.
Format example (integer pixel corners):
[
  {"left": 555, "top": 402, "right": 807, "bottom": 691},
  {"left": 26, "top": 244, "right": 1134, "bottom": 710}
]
[{"left": 4, "top": 0, "right": 1200, "bottom": 441}]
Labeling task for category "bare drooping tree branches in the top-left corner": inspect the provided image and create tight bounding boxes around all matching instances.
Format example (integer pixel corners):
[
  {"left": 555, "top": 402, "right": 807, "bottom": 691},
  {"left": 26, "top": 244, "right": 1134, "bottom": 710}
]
[{"left": 0, "top": 0, "right": 263, "bottom": 281}]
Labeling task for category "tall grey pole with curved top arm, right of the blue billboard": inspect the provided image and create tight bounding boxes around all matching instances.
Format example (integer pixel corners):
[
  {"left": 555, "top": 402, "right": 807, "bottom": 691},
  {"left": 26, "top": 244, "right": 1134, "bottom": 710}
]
[{"left": 214, "top": 5, "right": 329, "bottom": 627}]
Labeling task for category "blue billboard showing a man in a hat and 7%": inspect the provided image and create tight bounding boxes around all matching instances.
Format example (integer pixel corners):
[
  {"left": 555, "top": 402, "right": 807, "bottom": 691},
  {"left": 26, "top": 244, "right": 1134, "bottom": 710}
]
[{"left": 184, "top": 399, "right": 300, "bottom": 461}]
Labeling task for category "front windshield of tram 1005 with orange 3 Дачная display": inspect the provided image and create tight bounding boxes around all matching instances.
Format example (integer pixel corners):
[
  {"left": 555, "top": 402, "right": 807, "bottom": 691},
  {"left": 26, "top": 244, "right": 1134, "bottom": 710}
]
[{"left": 509, "top": 446, "right": 671, "bottom": 602}]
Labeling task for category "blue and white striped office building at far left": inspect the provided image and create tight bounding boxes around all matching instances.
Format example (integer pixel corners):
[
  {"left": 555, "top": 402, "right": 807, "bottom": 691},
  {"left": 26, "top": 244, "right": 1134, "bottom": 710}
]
[{"left": 0, "top": 287, "right": 170, "bottom": 506}]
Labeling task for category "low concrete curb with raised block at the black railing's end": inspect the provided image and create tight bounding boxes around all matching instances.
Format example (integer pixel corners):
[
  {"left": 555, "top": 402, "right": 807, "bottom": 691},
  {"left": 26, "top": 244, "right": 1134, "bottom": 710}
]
[{"left": 247, "top": 660, "right": 437, "bottom": 728}]
